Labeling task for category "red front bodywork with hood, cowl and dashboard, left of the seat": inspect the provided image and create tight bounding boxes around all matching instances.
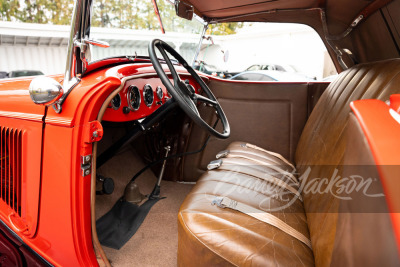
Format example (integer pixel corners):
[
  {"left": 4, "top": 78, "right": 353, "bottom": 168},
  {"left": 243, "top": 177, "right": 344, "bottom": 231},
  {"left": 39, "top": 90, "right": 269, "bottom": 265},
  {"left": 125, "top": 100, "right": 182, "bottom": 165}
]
[{"left": 0, "top": 60, "right": 205, "bottom": 266}]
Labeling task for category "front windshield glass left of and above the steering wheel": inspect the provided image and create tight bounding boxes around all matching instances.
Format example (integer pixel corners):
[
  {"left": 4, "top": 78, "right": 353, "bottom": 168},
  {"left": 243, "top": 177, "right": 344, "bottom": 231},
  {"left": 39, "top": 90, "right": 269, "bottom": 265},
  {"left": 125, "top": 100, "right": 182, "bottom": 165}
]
[{"left": 90, "top": 0, "right": 203, "bottom": 64}]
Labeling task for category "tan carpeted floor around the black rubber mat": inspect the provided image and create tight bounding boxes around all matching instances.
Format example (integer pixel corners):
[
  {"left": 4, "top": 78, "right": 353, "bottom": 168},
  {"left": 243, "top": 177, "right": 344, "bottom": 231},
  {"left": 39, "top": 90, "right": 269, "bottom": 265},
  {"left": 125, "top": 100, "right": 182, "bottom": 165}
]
[{"left": 96, "top": 151, "right": 193, "bottom": 266}]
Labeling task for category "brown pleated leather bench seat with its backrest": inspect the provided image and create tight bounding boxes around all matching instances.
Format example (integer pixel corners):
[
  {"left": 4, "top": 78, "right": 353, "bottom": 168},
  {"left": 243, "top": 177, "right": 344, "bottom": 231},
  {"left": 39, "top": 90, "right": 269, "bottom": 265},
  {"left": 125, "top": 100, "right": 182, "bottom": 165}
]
[{"left": 178, "top": 59, "right": 400, "bottom": 266}]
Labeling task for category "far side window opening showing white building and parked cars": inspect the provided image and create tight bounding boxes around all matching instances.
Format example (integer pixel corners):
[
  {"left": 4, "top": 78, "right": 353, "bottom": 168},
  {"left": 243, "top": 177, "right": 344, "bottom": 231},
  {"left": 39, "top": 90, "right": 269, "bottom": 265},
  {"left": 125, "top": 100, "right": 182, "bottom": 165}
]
[{"left": 195, "top": 22, "right": 336, "bottom": 82}]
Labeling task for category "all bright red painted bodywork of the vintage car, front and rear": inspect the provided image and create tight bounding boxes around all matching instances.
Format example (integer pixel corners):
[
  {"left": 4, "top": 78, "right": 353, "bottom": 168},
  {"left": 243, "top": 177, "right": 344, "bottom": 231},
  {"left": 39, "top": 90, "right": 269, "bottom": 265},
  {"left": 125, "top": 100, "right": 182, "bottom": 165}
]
[{"left": 0, "top": 0, "right": 400, "bottom": 266}]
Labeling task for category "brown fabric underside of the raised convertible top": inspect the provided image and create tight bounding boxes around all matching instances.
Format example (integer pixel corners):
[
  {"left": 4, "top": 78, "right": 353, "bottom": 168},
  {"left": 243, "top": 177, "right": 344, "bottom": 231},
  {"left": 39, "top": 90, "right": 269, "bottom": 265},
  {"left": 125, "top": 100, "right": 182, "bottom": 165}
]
[{"left": 183, "top": 0, "right": 400, "bottom": 71}]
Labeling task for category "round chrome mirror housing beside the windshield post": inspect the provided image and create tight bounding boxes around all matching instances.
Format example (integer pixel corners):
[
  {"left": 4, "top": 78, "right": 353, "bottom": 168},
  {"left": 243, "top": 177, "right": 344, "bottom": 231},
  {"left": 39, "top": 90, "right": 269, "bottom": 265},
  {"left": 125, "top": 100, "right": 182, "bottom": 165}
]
[{"left": 29, "top": 76, "right": 64, "bottom": 106}]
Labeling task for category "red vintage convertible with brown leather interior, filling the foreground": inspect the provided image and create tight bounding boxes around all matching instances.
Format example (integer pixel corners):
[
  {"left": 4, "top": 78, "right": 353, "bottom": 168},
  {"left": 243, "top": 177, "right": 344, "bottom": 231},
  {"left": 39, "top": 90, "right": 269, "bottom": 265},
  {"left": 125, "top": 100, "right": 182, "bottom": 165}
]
[{"left": 0, "top": 0, "right": 400, "bottom": 266}]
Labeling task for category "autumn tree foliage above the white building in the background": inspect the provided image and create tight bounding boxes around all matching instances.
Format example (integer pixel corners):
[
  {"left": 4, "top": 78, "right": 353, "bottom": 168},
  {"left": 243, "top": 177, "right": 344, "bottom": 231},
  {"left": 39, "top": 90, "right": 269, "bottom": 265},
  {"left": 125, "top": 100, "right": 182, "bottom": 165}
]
[{"left": 0, "top": 0, "right": 243, "bottom": 35}]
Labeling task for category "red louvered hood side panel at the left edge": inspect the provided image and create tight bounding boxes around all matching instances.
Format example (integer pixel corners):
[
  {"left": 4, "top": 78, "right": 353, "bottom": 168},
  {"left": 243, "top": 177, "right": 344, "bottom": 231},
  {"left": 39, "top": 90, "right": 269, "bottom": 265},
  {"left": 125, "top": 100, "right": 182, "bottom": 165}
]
[{"left": 0, "top": 117, "right": 42, "bottom": 240}]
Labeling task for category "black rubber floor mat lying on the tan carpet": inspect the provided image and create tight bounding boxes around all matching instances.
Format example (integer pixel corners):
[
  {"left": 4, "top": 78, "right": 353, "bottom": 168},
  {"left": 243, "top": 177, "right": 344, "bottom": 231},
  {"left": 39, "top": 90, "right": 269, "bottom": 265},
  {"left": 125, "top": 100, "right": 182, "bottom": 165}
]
[{"left": 96, "top": 198, "right": 160, "bottom": 249}]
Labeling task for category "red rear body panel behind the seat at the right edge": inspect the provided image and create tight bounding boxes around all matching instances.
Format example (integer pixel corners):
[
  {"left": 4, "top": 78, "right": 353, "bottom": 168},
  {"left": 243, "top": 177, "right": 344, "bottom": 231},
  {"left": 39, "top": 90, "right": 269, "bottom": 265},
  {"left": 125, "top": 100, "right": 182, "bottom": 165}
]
[{"left": 350, "top": 95, "right": 400, "bottom": 253}]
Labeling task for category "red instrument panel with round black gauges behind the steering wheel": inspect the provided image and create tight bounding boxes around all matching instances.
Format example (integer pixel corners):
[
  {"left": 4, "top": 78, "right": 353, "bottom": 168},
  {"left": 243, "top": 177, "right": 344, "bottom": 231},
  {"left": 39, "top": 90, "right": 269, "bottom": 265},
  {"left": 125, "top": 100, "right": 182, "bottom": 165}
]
[{"left": 103, "top": 75, "right": 184, "bottom": 122}]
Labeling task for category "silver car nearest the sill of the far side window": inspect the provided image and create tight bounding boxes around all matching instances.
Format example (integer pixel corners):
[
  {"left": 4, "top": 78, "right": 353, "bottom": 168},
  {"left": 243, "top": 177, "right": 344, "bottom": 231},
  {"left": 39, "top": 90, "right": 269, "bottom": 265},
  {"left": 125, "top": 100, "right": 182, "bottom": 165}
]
[{"left": 230, "top": 70, "right": 312, "bottom": 82}]
